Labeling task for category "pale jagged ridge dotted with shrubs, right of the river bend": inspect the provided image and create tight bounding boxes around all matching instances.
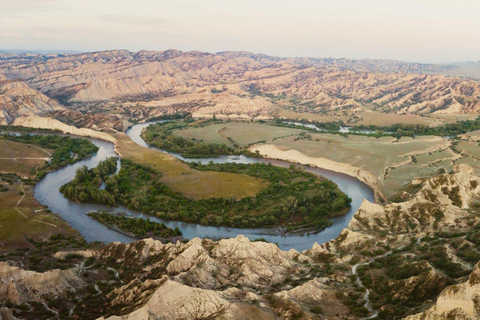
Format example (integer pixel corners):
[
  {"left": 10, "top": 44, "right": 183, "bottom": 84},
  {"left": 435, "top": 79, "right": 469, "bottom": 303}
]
[{"left": 349, "top": 164, "right": 480, "bottom": 233}]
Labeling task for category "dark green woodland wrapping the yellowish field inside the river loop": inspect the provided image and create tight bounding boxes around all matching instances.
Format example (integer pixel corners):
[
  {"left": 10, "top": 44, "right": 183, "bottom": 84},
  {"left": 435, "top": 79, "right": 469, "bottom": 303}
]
[{"left": 60, "top": 157, "right": 351, "bottom": 231}]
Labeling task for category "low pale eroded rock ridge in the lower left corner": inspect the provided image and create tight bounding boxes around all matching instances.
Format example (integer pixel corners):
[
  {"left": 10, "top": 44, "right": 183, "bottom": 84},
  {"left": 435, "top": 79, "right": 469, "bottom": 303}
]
[{"left": 0, "top": 262, "right": 84, "bottom": 304}]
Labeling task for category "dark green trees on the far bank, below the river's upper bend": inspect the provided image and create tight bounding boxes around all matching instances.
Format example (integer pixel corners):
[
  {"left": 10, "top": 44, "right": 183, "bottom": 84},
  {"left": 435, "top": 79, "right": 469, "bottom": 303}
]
[{"left": 142, "top": 122, "right": 241, "bottom": 158}]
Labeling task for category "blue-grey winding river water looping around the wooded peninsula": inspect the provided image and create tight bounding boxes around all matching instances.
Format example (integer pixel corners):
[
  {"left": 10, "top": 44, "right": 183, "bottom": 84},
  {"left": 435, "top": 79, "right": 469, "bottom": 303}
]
[{"left": 34, "top": 123, "right": 374, "bottom": 251}]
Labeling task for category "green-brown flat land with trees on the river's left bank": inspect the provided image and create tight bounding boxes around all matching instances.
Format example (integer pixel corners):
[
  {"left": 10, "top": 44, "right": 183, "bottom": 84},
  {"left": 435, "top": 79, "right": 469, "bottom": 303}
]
[{"left": 0, "top": 136, "right": 96, "bottom": 249}]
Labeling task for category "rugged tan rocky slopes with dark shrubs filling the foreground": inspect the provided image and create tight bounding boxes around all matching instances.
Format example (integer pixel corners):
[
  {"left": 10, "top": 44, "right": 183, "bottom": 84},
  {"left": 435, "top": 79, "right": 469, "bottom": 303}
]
[{"left": 0, "top": 161, "right": 480, "bottom": 319}]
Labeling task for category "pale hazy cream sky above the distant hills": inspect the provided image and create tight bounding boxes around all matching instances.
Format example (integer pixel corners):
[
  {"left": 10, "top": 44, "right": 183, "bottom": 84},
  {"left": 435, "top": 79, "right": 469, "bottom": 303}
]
[{"left": 0, "top": 0, "right": 480, "bottom": 62}]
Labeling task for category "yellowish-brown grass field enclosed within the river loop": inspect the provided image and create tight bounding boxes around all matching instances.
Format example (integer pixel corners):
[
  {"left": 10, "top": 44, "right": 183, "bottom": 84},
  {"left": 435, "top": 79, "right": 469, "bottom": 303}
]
[{"left": 115, "top": 134, "right": 267, "bottom": 199}]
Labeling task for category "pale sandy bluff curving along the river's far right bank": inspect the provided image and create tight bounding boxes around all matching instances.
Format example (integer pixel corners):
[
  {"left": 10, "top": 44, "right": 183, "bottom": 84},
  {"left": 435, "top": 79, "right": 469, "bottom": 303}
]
[{"left": 249, "top": 144, "right": 386, "bottom": 203}]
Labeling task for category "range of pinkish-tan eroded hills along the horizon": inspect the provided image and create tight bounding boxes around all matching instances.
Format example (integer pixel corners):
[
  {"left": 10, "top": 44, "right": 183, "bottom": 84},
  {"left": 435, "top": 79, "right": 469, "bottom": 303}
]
[{"left": 0, "top": 50, "right": 480, "bottom": 125}]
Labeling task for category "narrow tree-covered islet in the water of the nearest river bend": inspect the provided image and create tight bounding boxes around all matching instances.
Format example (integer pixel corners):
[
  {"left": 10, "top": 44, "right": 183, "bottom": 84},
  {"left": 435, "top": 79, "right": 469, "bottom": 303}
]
[{"left": 88, "top": 212, "right": 182, "bottom": 238}]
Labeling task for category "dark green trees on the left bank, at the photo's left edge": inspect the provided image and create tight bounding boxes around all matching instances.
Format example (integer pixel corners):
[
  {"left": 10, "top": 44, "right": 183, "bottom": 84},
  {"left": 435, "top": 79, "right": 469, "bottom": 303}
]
[{"left": 0, "top": 134, "right": 98, "bottom": 179}]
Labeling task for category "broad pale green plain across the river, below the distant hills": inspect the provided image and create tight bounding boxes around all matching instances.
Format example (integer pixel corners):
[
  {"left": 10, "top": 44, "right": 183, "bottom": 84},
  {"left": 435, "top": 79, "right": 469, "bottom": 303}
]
[{"left": 158, "top": 121, "right": 480, "bottom": 197}]
